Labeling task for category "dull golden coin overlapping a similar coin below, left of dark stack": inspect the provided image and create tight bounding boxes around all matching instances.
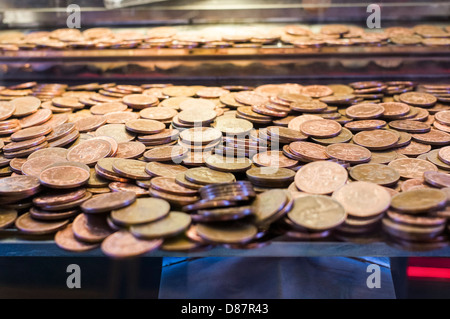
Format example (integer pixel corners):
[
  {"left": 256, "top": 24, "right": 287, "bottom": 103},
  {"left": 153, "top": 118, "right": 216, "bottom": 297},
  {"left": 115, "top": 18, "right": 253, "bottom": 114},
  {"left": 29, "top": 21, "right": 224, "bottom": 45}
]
[{"left": 111, "top": 198, "right": 170, "bottom": 226}]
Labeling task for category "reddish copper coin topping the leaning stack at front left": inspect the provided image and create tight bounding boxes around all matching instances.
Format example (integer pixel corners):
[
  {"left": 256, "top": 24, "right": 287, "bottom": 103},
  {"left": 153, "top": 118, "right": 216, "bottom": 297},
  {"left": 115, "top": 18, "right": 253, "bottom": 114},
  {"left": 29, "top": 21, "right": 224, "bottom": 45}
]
[{"left": 39, "top": 165, "right": 90, "bottom": 188}]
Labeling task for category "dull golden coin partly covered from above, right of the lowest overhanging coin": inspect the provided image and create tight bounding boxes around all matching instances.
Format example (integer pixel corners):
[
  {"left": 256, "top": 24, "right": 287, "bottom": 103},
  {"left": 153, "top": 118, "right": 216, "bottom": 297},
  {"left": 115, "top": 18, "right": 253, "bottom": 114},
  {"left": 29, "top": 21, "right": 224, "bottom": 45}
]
[{"left": 130, "top": 211, "right": 191, "bottom": 239}]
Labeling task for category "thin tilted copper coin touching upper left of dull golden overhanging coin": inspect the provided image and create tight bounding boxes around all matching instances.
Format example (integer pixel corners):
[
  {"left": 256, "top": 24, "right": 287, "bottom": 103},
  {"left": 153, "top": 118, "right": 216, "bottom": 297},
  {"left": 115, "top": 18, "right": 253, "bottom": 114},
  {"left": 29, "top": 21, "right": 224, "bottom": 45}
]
[{"left": 81, "top": 192, "right": 136, "bottom": 214}]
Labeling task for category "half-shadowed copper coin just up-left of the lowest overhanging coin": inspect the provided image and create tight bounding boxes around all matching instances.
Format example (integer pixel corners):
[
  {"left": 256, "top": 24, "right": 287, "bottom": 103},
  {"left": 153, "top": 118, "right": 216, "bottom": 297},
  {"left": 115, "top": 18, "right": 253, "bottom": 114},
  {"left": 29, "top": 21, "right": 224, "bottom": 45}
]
[{"left": 72, "top": 214, "right": 114, "bottom": 243}]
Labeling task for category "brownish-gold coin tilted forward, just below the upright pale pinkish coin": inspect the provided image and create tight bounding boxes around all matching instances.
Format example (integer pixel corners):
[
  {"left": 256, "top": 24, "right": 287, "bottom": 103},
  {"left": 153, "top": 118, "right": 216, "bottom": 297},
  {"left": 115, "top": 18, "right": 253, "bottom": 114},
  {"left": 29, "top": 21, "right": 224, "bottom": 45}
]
[{"left": 287, "top": 195, "right": 347, "bottom": 231}]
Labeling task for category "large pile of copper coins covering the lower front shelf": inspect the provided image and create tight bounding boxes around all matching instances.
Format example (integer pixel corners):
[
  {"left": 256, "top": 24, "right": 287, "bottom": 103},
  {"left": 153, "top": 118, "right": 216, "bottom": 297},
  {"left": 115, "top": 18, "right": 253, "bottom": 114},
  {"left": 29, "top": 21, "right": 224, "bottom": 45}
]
[{"left": 0, "top": 81, "right": 450, "bottom": 257}]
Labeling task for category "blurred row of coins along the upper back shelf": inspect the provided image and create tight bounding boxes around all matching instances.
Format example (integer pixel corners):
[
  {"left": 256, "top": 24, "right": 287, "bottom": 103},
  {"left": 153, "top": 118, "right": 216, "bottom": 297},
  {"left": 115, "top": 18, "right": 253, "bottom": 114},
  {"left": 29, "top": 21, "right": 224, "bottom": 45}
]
[{"left": 0, "top": 24, "right": 450, "bottom": 51}]
